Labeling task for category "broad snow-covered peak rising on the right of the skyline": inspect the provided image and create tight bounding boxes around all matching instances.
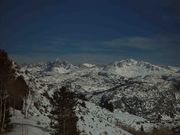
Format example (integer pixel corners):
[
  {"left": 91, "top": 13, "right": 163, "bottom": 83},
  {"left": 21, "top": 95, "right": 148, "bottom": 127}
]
[{"left": 102, "top": 59, "right": 177, "bottom": 77}]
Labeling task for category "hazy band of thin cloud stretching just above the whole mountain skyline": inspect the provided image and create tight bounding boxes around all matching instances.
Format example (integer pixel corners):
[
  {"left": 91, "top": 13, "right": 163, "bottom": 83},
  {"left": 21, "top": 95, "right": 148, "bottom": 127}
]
[{"left": 8, "top": 35, "right": 180, "bottom": 66}]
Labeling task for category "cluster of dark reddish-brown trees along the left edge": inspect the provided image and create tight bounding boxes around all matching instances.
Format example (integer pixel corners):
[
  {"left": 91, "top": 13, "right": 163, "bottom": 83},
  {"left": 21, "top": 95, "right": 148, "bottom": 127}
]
[{"left": 0, "top": 49, "right": 28, "bottom": 133}]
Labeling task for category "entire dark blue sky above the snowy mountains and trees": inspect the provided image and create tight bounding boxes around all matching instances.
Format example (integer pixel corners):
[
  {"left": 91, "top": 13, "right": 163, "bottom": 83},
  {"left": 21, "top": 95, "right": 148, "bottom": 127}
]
[{"left": 0, "top": 0, "right": 180, "bottom": 66}]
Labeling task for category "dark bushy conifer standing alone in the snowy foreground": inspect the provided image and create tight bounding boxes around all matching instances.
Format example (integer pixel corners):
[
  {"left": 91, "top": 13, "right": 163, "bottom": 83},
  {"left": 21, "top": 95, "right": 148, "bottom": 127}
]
[{"left": 51, "top": 87, "right": 79, "bottom": 135}]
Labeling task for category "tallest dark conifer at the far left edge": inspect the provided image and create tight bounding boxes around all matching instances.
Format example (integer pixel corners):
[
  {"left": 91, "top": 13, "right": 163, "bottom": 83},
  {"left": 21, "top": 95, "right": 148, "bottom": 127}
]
[{"left": 0, "top": 49, "right": 15, "bottom": 132}]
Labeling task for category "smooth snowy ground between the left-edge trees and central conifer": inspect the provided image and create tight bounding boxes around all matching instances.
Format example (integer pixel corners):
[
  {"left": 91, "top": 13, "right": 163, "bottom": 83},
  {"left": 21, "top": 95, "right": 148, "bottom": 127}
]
[{"left": 4, "top": 110, "right": 50, "bottom": 135}]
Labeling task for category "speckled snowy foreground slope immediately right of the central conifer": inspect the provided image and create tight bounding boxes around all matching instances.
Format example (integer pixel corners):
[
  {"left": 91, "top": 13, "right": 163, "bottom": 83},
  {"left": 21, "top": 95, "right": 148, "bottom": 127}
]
[{"left": 77, "top": 102, "right": 133, "bottom": 135}]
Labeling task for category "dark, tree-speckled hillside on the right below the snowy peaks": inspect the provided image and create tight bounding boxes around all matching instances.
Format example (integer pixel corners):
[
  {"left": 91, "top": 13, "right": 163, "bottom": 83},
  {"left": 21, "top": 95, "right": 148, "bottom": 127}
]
[{"left": 89, "top": 79, "right": 176, "bottom": 120}]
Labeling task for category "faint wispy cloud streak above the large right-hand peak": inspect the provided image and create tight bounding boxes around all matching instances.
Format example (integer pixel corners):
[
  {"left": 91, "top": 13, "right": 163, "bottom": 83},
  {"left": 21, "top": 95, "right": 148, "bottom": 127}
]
[{"left": 104, "top": 35, "right": 180, "bottom": 50}]
